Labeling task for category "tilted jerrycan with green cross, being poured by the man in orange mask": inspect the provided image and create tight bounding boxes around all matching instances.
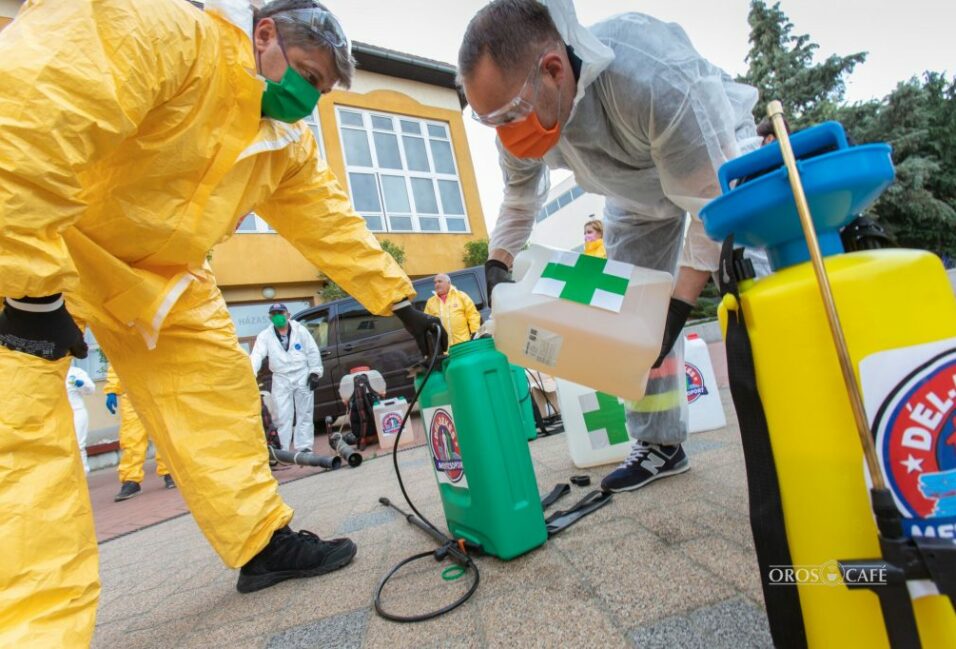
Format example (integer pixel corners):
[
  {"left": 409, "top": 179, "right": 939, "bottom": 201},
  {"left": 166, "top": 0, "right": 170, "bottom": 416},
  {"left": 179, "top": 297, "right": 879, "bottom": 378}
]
[{"left": 491, "top": 245, "right": 673, "bottom": 401}]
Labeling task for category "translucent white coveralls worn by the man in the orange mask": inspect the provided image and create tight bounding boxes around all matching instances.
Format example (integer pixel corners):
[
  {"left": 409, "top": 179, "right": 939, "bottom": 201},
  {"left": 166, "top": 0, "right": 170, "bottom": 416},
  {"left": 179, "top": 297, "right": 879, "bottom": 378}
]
[{"left": 489, "top": 0, "right": 760, "bottom": 444}]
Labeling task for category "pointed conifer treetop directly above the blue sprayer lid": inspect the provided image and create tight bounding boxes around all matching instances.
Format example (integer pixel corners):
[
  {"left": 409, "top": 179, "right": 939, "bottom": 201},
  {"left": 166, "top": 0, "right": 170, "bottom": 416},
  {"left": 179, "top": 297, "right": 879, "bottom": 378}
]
[{"left": 739, "top": 0, "right": 866, "bottom": 128}]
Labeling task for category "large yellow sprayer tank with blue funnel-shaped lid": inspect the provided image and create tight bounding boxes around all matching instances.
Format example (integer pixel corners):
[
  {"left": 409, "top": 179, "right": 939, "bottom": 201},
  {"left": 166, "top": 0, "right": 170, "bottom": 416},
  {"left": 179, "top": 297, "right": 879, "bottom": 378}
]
[{"left": 701, "top": 122, "right": 956, "bottom": 649}]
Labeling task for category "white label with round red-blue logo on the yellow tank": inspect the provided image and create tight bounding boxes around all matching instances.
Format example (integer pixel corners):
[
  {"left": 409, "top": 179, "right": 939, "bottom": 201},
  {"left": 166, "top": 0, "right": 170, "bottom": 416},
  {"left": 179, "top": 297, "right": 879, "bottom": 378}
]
[{"left": 860, "top": 339, "right": 956, "bottom": 539}]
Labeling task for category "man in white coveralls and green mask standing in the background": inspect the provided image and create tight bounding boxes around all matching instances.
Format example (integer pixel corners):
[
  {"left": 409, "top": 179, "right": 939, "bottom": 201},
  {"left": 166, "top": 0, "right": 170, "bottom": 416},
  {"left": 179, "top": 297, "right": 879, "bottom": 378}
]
[{"left": 250, "top": 304, "right": 324, "bottom": 453}]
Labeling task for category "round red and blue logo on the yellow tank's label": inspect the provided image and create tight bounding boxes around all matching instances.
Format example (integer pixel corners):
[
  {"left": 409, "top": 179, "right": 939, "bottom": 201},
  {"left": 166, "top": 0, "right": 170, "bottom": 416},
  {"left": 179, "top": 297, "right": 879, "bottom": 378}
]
[{"left": 873, "top": 349, "right": 956, "bottom": 536}]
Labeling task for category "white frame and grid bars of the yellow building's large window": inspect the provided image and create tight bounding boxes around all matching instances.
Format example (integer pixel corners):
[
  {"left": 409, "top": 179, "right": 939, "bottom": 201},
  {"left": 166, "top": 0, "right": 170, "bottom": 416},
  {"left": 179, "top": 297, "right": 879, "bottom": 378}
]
[{"left": 336, "top": 105, "right": 472, "bottom": 235}]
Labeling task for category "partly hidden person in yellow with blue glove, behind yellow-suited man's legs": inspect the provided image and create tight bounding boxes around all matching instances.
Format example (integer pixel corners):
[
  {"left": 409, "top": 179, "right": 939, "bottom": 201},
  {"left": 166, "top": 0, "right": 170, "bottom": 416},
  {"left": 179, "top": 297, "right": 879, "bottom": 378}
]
[{"left": 103, "top": 367, "right": 176, "bottom": 502}]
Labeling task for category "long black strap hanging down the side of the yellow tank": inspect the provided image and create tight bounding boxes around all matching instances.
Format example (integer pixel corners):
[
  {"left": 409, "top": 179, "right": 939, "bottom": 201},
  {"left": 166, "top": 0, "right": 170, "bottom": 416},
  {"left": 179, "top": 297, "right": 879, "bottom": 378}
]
[{"left": 718, "top": 235, "right": 807, "bottom": 649}]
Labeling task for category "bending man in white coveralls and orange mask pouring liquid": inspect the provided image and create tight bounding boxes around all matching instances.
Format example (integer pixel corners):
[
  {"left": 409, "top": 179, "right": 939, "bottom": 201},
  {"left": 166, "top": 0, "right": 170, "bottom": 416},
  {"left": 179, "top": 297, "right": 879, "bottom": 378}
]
[{"left": 458, "top": 0, "right": 760, "bottom": 491}]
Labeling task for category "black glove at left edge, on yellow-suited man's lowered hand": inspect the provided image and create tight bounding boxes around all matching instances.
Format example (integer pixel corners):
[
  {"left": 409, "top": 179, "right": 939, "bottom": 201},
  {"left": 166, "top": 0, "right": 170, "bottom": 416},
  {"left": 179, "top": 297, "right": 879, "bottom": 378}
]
[{"left": 0, "top": 293, "right": 89, "bottom": 361}]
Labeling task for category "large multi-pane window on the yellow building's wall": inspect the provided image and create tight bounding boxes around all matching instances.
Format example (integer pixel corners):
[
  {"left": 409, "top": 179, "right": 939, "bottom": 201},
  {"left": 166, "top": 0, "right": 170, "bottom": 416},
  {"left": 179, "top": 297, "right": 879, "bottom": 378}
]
[{"left": 338, "top": 107, "right": 469, "bottom": 233}]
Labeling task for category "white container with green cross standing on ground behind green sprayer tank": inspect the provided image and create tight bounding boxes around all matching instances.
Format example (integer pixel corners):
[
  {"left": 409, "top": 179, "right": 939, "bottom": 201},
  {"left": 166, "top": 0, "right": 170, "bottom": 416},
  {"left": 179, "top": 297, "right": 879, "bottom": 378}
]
[{"left": 556, "top": 379, "right": 633, "bottom": 469}]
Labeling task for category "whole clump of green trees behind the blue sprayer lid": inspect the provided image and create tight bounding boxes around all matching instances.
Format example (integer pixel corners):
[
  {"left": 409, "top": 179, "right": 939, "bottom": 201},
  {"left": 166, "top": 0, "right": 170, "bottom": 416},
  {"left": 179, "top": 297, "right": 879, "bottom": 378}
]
[{"left": 740, "top": 0, "right": 956, "bottom": 257}]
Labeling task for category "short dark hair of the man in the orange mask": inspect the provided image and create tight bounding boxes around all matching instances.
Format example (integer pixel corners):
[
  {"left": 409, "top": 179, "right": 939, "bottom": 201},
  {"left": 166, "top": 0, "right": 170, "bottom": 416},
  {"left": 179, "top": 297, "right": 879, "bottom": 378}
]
[{"left": 458, "top": 0, "right": 562, "bottom": 84}]
